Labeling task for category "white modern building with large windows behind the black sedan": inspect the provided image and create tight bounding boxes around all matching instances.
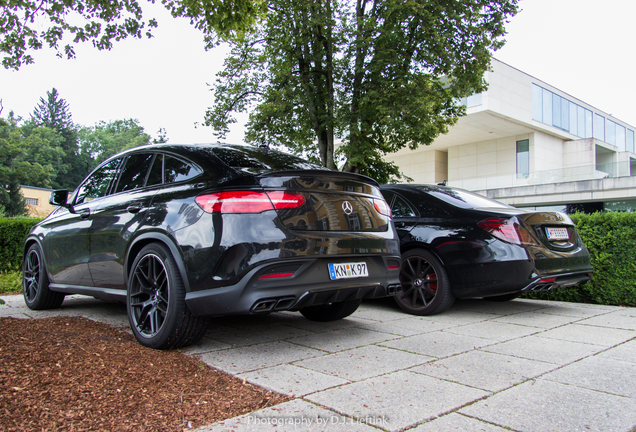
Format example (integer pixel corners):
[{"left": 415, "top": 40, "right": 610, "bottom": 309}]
[{"left": 386, "top": 59, "right": 636, "bottom": 211}]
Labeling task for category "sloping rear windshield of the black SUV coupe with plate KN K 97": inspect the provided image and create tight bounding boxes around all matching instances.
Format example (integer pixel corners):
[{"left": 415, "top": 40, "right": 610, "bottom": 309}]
[{"left": 211, "top": 146, "right": 326, "bottom": 174}]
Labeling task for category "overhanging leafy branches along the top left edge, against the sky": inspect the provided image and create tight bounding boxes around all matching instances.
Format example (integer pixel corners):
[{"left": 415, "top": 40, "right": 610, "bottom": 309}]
[{"left": 0, "top": 0, "right": 264, "bottom": 70}]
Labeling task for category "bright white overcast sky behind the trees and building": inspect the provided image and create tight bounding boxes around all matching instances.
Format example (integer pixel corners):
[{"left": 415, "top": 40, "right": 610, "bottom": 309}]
[{"left": 0, "top": 0, "right": 636, "bottom": 143}]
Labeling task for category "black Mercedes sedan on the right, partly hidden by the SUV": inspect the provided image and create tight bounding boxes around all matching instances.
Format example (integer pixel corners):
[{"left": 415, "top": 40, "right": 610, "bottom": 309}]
[{"left": 381, "top": 185, "right": 592, "bottom": 315}]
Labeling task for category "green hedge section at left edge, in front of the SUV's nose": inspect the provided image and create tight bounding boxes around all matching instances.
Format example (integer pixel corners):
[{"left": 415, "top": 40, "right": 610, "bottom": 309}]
[{"left": 0, "top": 218, "right": 41, "bottom": 272}]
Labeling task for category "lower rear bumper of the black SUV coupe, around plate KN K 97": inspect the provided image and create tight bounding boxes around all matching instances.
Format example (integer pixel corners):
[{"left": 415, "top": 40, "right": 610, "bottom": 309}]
[{"left": 185, "top": 255, "right": 400, "bottom": 316}]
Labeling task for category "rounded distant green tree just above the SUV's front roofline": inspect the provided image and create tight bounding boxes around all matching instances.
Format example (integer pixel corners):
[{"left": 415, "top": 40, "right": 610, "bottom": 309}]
[{"left": 78, "top": 119, "right": 155, "bottom": 171}]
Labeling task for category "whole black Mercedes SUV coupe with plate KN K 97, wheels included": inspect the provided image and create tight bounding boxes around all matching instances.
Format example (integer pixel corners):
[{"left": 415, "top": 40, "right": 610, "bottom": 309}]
[{"left": 23, "top": 145, "right": 400, "bottom": 349}]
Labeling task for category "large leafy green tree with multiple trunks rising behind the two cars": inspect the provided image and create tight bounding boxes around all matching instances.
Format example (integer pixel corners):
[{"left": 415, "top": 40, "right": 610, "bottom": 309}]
[{"left": 206, "top": 0, "right": 518, "bottom": 181}]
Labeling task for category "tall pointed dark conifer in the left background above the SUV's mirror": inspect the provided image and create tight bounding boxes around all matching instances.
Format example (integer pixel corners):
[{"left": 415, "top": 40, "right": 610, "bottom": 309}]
[{"left": 25, "top": 88, "right": 86, "bottom": 189}]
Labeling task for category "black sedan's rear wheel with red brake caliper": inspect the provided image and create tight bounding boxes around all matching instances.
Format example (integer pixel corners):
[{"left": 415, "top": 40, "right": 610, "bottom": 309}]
[{"left": 394, "top": 249, "right": 455, "bottom": 315}]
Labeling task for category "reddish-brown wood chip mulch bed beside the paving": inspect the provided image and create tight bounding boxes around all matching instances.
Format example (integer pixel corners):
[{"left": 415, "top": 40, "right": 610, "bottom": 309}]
[{"left": 0, "top": 317, "right": 290, "bottom": 431}]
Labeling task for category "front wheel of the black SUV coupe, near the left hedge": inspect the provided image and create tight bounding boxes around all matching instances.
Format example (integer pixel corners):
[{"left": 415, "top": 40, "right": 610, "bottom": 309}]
[{"left": 22, "top": 243, "right": 64, "bottom": 310}]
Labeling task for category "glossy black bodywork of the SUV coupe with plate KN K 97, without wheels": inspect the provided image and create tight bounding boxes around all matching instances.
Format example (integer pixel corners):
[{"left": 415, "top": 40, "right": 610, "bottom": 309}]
[{"left": 25, "top": 145, "right": 399, "bottom": 315}]
